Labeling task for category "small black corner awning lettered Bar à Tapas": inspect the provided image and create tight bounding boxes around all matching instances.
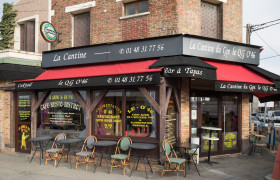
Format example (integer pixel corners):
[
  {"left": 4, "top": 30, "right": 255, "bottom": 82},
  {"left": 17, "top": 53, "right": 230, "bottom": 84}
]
[{"left": 150, "top": 56, "right": 217, "bottom": 80}]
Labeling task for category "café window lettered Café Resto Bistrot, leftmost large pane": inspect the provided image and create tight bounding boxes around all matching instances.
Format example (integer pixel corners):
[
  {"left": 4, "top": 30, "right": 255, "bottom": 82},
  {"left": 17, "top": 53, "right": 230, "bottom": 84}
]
[{"left": 37, "top": 91, "right": 86, "bottom": 137}]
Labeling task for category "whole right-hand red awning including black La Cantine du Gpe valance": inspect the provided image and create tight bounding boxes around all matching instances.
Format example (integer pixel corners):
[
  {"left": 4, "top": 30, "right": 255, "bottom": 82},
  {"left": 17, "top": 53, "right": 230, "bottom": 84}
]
[{"left": 204, "top": 60, "right": 279, "bottom": 93}]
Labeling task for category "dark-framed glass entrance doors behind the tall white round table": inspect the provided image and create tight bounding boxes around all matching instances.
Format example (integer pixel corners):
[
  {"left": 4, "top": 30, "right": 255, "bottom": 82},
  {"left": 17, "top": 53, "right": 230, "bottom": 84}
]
[{"left": 191, "top": 94, "right": 240, "bottom": 155}]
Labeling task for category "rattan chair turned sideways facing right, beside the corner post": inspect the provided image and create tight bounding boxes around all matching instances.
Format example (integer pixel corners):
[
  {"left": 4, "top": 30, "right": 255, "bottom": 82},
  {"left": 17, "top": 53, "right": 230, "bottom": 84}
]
[{"left": 161, "top": 140, "right": 186, "bottom": 180}]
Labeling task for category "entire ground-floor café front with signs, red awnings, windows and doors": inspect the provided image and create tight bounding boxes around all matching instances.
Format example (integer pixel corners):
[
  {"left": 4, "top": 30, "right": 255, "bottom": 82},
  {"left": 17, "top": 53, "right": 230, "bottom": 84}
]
[{"left": 15, "top": 34, "right": 280, "bottom": 156}]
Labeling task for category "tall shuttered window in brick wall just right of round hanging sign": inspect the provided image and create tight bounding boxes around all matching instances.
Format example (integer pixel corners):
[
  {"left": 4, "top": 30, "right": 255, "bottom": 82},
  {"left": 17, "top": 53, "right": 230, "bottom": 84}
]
[{"left": 74, "top": 12, "right": 90, "bottom": 47}]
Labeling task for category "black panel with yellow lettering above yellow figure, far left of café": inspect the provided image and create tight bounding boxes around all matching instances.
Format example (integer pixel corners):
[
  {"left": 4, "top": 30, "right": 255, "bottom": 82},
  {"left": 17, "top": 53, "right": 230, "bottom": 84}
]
[{"left": 18, "top": 95, "right": 31, "bottom": 122}]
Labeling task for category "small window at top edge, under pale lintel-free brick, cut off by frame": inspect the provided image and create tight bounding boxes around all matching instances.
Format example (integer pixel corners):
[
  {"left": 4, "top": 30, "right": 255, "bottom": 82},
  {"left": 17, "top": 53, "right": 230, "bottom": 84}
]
[{"left": 124, "top": 0, "right": 148, "bottom": 16}]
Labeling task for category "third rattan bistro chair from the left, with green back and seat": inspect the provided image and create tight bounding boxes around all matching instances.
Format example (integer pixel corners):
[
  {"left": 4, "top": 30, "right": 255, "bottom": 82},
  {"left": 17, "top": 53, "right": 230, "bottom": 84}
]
[{"left": 111, "top": 137, "right": 132, "bottom": 175}]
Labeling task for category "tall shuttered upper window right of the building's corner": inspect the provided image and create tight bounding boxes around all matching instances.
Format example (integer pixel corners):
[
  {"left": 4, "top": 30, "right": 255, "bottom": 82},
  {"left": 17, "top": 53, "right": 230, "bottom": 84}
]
[{"left": 201, "top": 1, "right": 222, "bottom": 38}]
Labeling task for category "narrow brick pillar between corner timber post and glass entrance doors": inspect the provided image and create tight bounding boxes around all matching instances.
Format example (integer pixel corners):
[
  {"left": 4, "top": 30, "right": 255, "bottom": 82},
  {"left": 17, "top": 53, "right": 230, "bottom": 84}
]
[{"left": 180, "top": 78, "right": 190, "bottom": 142}]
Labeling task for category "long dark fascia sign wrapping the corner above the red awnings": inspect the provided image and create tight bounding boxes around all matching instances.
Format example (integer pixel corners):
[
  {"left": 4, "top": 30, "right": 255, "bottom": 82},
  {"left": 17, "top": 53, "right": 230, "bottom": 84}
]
[{"left": 42, "top": 35, "right": 260, "bottom": 68}]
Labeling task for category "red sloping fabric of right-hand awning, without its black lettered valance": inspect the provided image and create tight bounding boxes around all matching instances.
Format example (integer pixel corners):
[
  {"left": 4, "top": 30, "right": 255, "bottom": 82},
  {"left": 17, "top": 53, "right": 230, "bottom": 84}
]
[{"left": 204, "top": 60, "right": 274, "bottom": 85}]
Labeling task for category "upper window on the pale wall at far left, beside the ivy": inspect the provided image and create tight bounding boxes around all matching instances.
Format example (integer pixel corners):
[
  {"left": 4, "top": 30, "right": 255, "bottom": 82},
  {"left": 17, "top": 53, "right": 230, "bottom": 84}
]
[{"left": 20, "top": 21, "right": 35, "bottom": 52}]
